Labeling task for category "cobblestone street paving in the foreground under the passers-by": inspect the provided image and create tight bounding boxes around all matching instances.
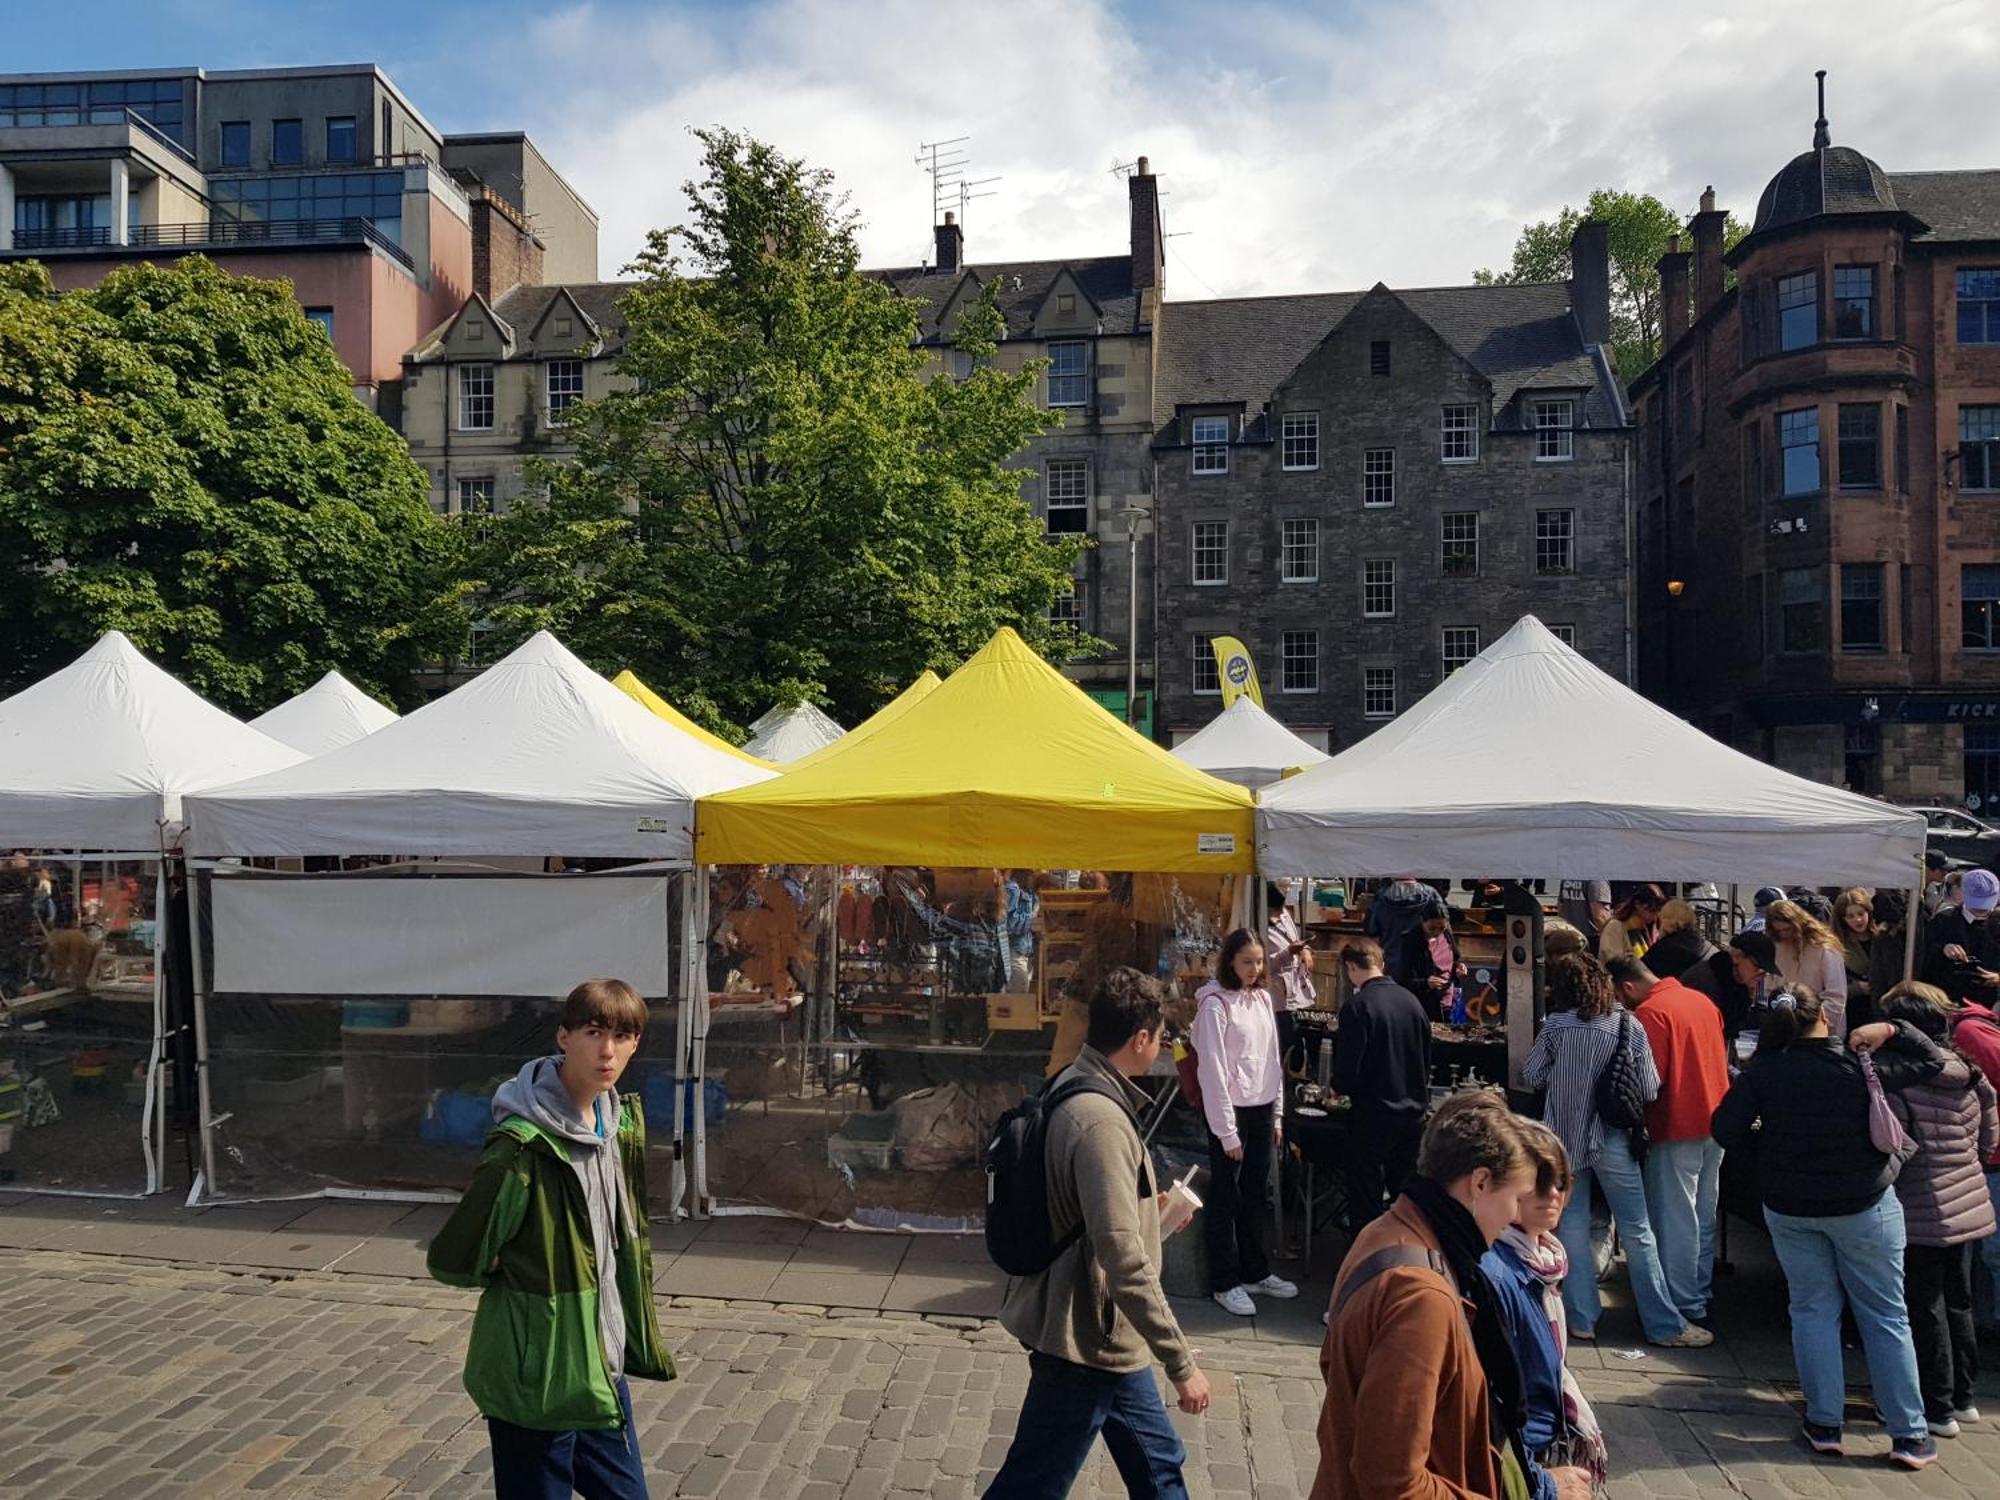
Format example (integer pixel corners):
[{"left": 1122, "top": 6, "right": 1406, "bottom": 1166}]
[{"left": 0, "top": 1206, "right": 2000, "bottom": 1500}]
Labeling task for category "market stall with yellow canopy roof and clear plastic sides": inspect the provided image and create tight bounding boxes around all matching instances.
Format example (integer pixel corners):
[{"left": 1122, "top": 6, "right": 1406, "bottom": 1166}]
[{"left": 696, "top": 630, "right": 1252, "bottom": 1226}]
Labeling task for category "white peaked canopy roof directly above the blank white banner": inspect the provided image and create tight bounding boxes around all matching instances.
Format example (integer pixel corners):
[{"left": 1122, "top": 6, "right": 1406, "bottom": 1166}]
[{"left": 188, "top": 632, "right": 772, "bottom": 864}]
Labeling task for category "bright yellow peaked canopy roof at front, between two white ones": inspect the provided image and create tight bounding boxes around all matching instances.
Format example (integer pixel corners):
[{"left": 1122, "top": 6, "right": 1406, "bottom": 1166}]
[{"left": 694, "top": 630, "right": 1256, "bottom": 874}]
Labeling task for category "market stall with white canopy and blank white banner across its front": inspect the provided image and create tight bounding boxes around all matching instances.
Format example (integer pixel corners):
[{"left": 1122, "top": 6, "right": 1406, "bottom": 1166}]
[{"left": 186, "top": 634, "right": 770, "bottom": 1208}]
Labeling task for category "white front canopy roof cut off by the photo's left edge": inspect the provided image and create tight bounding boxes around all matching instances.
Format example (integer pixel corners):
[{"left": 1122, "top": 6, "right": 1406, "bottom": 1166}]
[{"left": 0, "top": 630, "right": 302, "bottom": 858}]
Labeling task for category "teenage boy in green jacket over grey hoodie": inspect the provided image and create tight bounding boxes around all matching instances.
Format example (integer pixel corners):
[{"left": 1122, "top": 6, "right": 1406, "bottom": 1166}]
[{"left": 428, "top": 980, "right": 674, "bottom": 1500}]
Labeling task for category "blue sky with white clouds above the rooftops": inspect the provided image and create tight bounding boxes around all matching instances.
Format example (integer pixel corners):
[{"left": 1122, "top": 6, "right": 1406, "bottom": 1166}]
[{"left": 11, "top": 0, "right": 2000, "bottom": 300}]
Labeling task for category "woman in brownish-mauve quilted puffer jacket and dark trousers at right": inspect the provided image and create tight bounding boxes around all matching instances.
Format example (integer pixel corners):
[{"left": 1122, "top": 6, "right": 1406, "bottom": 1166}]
[{"left": 1882, "top": 984, "right": 2000, "bottom": 1438}]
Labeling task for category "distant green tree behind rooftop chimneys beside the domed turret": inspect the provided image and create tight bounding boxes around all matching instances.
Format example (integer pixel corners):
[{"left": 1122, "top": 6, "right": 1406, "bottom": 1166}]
[{"left": 1472, "top": 188, "right": 1744, "bottom": 380}]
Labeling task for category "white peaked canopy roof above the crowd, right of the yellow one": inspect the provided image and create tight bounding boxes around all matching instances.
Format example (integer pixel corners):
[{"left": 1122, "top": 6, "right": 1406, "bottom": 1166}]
[{"left": 1258, "top": 616, "right": 1924, "bottom": 888}]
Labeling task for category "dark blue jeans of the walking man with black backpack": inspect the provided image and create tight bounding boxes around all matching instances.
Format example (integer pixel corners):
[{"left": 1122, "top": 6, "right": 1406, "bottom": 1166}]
[{"left": 986, "top": 1352, "right": 1188, "bottom": 1500}]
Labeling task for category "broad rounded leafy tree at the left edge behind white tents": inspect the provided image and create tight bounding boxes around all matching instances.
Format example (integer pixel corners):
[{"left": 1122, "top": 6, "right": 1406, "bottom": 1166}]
[{"left": 0, "top": 256, "right": 466, "bottom": 712}]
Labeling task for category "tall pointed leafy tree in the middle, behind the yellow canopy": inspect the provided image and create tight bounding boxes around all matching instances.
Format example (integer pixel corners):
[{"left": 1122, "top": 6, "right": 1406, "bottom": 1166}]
[{"left": 472, "top": 130, "right": 1096, "bottom": 732}]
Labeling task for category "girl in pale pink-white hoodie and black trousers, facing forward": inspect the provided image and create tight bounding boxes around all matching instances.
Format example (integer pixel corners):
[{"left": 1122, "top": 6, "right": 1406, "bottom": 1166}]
[{"left": 1194, "top": 928, "right": 1298, "bottom": 1318}]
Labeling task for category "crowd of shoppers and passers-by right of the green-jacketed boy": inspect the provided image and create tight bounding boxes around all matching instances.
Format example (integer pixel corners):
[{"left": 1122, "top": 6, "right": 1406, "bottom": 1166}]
[{"left": 988, "top": 870, "right": 2000, "bottom": 1500}]
